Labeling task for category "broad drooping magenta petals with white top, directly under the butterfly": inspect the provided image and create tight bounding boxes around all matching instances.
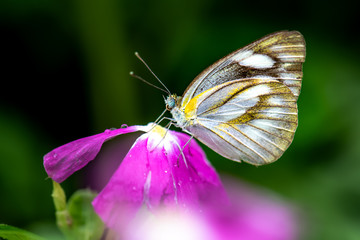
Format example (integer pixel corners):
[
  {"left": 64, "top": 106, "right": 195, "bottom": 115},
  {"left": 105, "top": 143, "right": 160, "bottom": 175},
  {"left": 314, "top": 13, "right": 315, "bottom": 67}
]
[{"left": 93, "top": 131, "right": 227, "bottom": 230}]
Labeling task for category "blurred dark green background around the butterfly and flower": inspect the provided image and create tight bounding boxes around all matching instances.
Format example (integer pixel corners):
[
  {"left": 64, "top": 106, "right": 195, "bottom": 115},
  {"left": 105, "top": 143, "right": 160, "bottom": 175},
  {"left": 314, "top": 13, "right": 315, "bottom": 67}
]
[{"left": 0, "top": 0, "right": 360, "bottom": 240}]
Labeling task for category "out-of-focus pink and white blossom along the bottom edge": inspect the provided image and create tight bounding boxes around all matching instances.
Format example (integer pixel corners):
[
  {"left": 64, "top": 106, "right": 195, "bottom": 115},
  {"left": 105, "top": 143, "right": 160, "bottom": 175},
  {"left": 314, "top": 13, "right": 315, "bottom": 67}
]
[{"left": 124, "top": 179, "right": 299, "bottom": 240}]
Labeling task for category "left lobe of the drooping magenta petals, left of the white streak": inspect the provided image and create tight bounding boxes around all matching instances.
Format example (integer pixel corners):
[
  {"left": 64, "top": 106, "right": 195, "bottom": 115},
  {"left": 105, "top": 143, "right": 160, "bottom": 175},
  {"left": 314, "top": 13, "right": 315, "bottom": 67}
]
[{"left": 93, "top": 136, "right": 149, "bottom": 227}]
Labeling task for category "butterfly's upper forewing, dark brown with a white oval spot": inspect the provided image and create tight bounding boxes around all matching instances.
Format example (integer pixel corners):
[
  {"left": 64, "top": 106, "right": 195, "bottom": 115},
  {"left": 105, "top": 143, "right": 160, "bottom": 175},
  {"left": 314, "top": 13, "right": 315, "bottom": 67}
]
[{"left": 182, "top": 31, "right": 305, "bottom": 106}]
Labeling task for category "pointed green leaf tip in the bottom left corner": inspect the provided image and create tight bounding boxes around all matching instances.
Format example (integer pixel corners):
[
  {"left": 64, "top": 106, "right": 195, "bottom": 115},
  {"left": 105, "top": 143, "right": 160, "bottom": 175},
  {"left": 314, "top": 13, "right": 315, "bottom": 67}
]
[{"left": 0, "top": 224, "right": 45, "bottom": 240}]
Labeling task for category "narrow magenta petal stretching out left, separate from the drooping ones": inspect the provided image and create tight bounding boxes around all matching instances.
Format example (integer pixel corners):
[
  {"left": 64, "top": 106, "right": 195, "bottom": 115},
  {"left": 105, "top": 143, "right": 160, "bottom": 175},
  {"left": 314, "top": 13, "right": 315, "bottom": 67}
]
[{"left": 44, "top": 126, "right": 143, "bottom": 183}]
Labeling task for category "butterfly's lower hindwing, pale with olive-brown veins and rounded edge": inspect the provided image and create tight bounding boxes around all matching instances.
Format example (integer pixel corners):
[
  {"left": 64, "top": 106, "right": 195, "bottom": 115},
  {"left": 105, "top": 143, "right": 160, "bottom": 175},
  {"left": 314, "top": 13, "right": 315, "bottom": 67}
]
[{"left": 187, "top": 79, "right": 297, "bottom": 165}]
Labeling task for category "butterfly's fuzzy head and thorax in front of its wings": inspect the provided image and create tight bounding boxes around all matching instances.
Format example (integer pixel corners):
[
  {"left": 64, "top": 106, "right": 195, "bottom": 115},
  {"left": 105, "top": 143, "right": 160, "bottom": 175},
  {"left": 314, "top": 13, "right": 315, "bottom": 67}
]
[{"left": 165, "top": 94, "right": 189, "bottom": 129}]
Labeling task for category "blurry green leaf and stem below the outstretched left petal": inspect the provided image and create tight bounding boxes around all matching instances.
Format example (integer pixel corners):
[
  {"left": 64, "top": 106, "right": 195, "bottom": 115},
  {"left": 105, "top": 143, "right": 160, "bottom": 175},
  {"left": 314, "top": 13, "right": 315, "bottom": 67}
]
[{"left": 52, "top": 181, "right": 104, "bottom": 240}]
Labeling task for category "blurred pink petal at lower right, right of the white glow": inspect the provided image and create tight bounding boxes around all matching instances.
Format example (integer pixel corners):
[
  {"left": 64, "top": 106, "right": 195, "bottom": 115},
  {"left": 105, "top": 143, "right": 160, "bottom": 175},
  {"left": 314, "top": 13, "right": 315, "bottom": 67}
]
[{"left": 208, "top": 179, "right": 299, "bottom": 240}]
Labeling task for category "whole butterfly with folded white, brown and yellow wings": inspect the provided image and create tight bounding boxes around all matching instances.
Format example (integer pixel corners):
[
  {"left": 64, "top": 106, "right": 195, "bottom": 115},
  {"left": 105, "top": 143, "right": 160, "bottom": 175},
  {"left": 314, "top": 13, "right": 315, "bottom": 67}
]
[{"left": 165, "top": 31, "right": 305, "bottom": 165}]
